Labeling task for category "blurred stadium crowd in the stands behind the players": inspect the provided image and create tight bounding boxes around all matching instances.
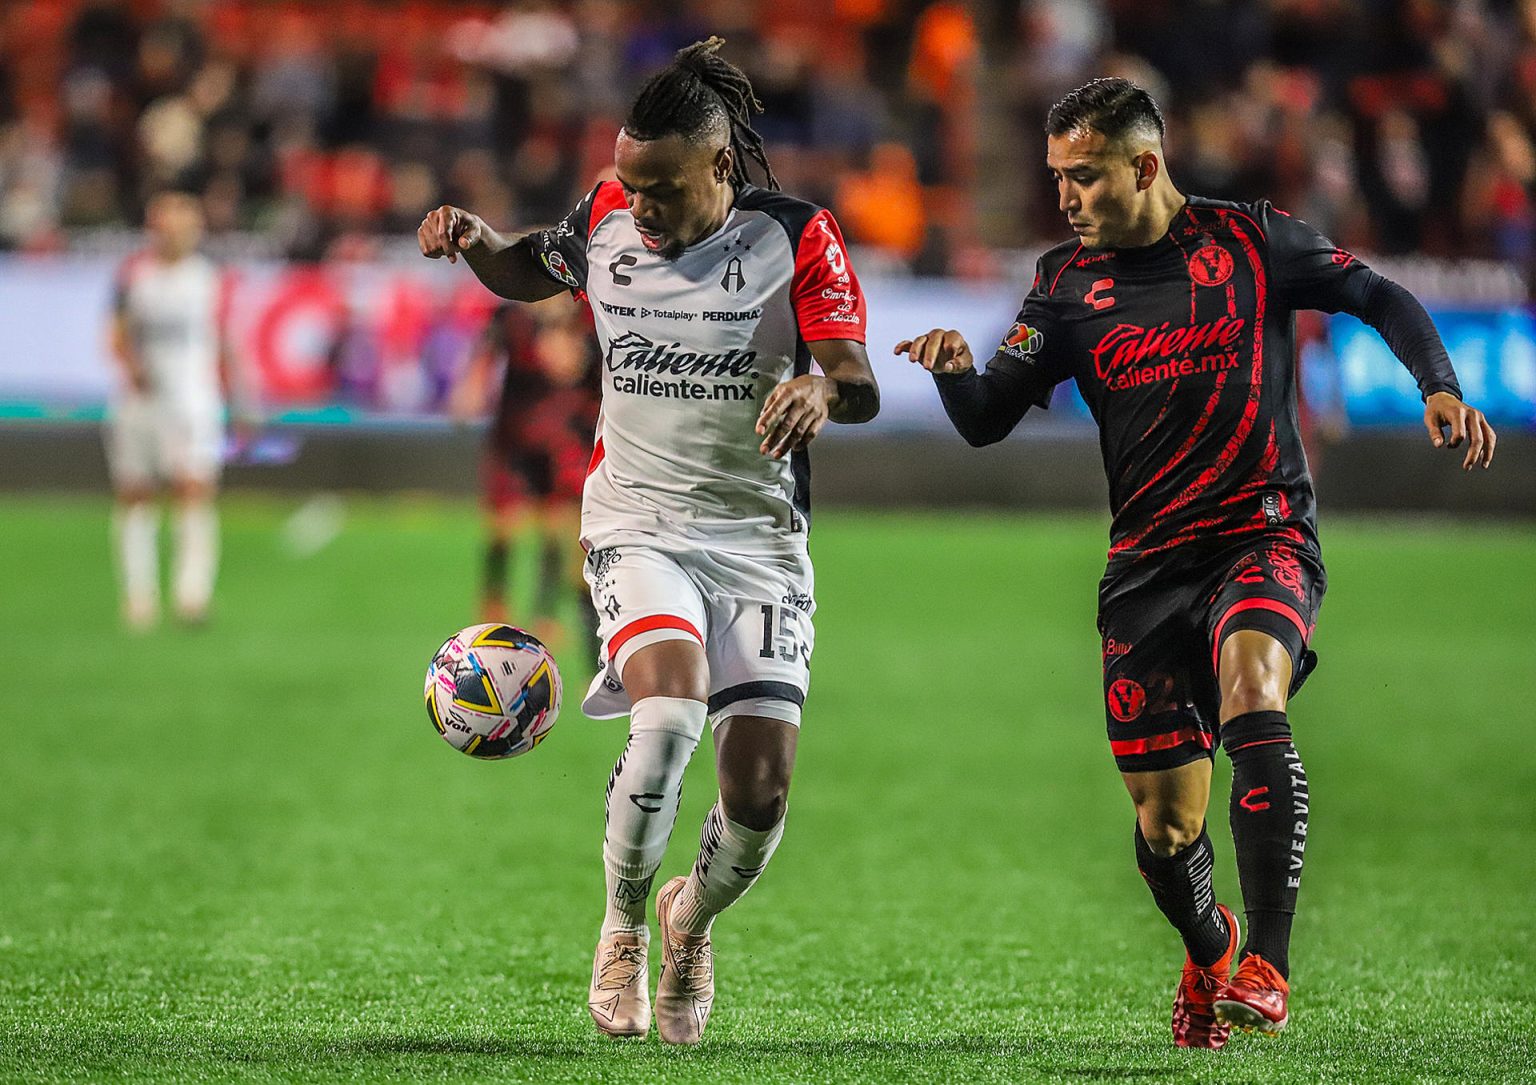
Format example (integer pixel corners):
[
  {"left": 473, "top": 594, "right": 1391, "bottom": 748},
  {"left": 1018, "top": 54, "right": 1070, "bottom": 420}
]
[{"left": 0, "top": 0, "right": 1536, "bottom": 277}]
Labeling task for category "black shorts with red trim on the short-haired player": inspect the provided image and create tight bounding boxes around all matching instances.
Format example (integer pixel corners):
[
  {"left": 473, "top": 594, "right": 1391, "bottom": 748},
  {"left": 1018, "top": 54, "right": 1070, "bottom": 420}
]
[{"left": 1098, "top": 539, "right": 1327, "bottom": 773}]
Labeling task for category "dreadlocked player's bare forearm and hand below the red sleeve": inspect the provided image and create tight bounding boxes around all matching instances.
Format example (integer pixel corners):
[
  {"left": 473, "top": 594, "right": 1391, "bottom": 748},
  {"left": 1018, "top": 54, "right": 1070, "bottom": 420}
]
[{"left": 757, "top": 340, "right": 880, "bottom": 460}]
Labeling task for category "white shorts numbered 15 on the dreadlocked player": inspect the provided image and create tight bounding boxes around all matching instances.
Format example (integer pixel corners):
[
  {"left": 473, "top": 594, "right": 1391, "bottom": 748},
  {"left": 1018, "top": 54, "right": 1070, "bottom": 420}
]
[{"left": 582, "top": 546, "right": 816, "bottom": 727}]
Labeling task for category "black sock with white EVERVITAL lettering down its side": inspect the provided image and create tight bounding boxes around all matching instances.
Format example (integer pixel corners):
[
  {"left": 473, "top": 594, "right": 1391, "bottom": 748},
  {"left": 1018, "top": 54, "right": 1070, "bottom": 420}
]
[{"left": 1221, "top": 712, "right": 1310, "bottom": 977}]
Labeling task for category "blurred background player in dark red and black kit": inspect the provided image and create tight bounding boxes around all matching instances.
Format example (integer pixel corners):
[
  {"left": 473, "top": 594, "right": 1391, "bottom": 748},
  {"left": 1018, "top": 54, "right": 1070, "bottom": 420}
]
[{"left": 452, "top": 298, "right": 602, "bottom": 647}]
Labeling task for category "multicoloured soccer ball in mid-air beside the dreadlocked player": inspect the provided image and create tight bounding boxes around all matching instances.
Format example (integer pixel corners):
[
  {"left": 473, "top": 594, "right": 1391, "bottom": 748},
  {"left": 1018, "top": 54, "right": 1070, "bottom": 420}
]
[{"left": 425, "top": 622, "right": 561, "bottom": 761}]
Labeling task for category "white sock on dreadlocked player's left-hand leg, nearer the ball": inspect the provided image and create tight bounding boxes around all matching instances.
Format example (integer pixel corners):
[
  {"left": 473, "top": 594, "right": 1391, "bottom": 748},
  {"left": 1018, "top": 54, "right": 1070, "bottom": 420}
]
[{"left": 602, "top": 698, "right": 707, "bottom": 936}]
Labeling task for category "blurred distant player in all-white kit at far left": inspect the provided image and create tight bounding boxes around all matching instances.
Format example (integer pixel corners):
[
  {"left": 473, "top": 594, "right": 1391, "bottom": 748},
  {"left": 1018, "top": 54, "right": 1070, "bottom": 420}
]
[{"left": 106, "top": 192, "right": 229, "bottom": 629}]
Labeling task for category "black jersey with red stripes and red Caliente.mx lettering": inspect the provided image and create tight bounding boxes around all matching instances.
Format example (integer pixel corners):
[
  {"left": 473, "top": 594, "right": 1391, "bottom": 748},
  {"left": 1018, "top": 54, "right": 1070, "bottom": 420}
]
[{"left": 938, "top": 198, "right": 1459, "bottom": 573}]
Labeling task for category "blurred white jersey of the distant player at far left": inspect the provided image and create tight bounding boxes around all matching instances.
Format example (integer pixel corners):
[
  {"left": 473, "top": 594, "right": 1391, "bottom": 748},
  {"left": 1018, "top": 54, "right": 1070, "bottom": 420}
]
[{"left": 114, "top": 254, "right": 223, "bottom": 413}]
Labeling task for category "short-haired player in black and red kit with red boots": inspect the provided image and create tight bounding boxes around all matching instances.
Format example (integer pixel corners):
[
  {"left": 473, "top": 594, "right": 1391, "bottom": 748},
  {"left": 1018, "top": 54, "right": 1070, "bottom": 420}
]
[{"left": 895, "top": 78, "right": 1495, "bottom": 1048}]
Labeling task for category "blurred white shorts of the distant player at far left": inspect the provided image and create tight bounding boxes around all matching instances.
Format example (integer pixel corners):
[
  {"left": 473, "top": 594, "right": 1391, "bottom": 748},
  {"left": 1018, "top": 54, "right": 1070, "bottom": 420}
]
[{"left": 106, "top": 395, "right": 224, "bottom": 487}]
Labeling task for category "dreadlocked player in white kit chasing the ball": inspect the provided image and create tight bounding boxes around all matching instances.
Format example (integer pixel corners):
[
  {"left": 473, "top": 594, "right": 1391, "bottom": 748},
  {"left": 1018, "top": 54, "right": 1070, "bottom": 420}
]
[{"left": 419, "top": 38, "right": 879, "bottom": 1044}]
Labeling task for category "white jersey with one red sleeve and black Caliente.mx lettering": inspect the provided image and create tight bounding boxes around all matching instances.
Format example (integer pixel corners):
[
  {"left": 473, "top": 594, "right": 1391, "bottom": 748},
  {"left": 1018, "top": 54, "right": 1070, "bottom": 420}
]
[{"left": 533, "top": 181, "right": 865, "bottom": 553}]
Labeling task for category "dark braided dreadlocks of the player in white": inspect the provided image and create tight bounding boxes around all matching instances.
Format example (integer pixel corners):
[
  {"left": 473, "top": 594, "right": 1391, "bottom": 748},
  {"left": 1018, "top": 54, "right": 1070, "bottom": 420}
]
[{"left": 624, "top": 37, "right": 779, "bottom": 189}]
